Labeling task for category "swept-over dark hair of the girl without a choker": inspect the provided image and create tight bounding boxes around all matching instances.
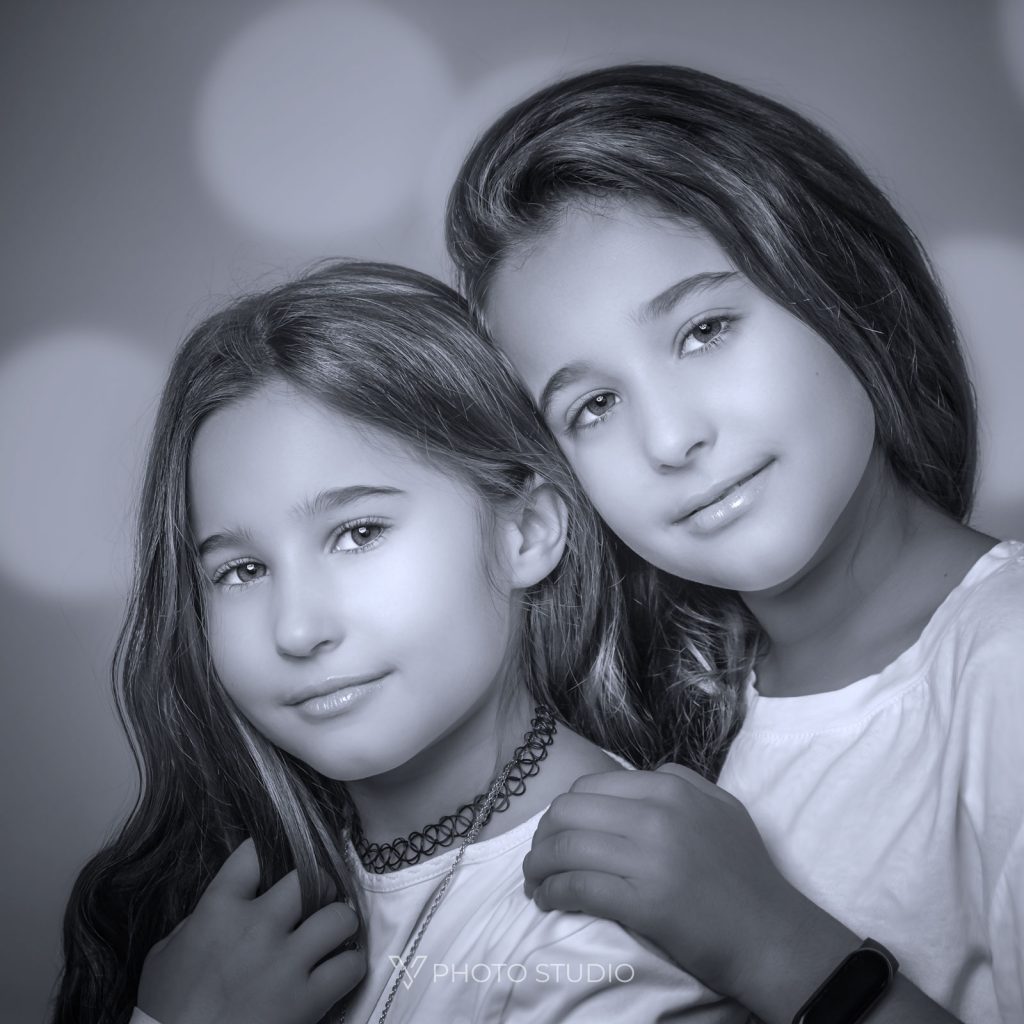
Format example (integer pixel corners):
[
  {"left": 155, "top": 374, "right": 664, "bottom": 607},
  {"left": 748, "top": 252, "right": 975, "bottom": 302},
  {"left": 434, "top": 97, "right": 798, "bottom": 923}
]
[{"left": 446, "top": 65, "right": 977, "bottom": 774}]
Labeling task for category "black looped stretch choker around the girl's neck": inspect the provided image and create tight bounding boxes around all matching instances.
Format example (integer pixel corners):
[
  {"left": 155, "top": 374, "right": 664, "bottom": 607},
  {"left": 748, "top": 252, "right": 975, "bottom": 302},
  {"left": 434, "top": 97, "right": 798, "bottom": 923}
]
[{"left": 352, "top": 705, "right": 557, "bottom": 874}]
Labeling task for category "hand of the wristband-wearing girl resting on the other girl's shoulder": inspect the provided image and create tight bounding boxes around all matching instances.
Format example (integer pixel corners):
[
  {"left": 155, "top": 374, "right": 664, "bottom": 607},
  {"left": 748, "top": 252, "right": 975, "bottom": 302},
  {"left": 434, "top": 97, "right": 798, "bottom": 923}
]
[{"left": 523, "top": 765, "right": 802, "bottom": 994}]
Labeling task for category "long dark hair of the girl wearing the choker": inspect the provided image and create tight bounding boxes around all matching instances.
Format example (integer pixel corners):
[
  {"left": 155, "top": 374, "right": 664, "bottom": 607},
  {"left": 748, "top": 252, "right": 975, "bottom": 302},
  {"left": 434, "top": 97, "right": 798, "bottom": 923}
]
[{"left": 54, "top": 262, "right": 660, "bottom": 1024}]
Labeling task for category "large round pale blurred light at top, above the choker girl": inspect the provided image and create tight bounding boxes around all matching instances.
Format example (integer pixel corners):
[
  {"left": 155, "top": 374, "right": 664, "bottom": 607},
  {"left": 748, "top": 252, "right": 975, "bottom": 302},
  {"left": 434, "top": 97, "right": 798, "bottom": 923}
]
[{"left": 197, "top": 0, "right": 453, "bottom": 248}]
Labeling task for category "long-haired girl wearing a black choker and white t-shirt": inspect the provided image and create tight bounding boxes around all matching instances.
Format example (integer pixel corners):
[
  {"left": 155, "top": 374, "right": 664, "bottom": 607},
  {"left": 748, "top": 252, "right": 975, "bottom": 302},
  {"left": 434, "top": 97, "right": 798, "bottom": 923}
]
[{"left": 55, "top": 262, "right": 745, "bottom": 1024}]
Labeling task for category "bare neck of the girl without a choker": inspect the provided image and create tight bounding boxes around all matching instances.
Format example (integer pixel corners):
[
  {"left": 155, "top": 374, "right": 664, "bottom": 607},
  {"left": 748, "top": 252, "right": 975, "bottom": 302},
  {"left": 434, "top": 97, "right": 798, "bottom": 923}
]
[{"left": 740, "top": 453, "right": 993, "bottom": 696}]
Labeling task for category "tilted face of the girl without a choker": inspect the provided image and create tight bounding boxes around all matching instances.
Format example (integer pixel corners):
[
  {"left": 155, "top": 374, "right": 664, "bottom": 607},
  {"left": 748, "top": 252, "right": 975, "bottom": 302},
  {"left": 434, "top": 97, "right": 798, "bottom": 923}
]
[{"left": 487, "top": 201, "right": 877, "bottom": 593}]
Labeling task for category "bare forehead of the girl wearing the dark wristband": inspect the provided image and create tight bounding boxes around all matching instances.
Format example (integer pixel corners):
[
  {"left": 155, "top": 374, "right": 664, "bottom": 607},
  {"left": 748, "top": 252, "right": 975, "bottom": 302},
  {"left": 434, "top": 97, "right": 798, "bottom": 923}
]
[{"left": 485, "top": 205, "right": 734, "bottom": 381}]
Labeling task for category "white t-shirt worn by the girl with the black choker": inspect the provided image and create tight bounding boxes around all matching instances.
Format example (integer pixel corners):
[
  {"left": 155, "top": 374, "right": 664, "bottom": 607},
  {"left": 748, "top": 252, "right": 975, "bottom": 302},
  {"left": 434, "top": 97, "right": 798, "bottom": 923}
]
[{"left": 346, "top": 813, "right": 746, "bottom": 1024}]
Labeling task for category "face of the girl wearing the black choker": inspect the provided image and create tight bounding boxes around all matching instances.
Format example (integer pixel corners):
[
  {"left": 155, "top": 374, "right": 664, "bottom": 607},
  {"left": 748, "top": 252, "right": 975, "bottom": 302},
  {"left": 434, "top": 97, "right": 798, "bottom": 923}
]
[{"left": 189, "top": 385, "right": 514, "bottom": 780}]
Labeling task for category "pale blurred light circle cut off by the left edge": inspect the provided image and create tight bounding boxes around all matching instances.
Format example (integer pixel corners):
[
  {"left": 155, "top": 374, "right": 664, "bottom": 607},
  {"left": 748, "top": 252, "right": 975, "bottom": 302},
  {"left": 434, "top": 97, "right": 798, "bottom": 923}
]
[{"left": 0, "top": 332, "right": 166, "bottom": 599}]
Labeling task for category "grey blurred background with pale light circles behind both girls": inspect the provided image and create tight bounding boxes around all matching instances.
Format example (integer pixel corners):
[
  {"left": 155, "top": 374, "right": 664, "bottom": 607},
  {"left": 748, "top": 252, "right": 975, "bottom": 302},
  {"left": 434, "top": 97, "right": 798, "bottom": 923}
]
[{"left": 0, "top": 0, "right": 1024, "bottom": 1024}]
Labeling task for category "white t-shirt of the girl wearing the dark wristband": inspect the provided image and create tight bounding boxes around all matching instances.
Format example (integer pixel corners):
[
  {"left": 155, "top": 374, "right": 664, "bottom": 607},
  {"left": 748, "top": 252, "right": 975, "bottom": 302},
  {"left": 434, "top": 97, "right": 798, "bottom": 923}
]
[{"left": 719, "top": 541, "right": 1024, "bottom": 1024}]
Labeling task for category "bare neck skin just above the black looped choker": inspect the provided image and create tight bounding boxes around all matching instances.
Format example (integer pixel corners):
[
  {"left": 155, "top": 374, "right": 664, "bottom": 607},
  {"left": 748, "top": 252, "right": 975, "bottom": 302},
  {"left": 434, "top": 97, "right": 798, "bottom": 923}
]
[{"left": 345, "top": 687, "right": 534, "bottom": 843}]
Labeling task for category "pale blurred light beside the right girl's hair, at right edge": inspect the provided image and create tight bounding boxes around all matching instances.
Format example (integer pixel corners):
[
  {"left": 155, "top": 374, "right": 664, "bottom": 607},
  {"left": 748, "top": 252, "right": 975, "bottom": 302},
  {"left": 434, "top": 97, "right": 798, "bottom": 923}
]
[{"left": 933, "top": 237, "right": 1024, "bottom": 538}]
